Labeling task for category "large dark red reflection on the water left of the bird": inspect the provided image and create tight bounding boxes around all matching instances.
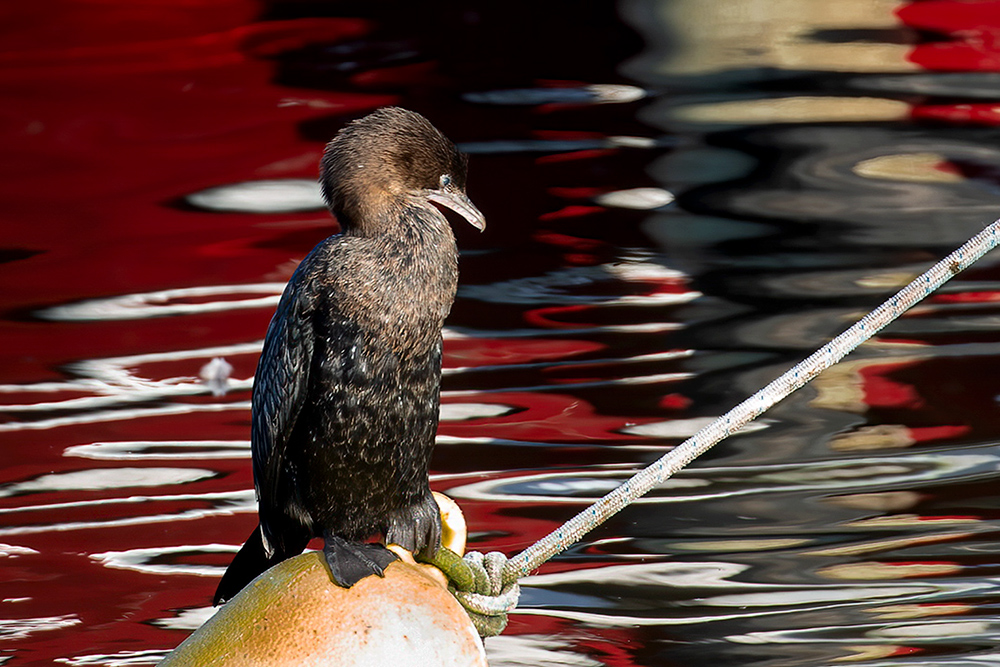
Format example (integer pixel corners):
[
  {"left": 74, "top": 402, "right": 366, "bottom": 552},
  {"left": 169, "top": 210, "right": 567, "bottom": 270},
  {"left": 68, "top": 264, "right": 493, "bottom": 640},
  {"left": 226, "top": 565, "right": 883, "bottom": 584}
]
[{"left": 0, "top": 2, "right": 398, "bottom": 664}]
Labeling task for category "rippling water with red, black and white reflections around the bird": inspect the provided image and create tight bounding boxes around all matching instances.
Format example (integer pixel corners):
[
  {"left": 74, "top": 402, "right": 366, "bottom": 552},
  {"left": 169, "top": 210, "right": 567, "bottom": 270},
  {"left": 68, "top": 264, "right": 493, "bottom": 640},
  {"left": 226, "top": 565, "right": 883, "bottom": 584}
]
[{"left": 0, "top": 0, "right": 1000, "bottom": 667}]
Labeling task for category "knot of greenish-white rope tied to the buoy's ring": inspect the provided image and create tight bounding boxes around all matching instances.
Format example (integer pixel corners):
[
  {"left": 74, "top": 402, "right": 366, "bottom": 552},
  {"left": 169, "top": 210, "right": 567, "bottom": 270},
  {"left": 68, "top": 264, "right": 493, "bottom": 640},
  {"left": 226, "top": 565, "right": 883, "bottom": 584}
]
[{"left": 429, "top": 547, "right": 521, "bottom": 637}]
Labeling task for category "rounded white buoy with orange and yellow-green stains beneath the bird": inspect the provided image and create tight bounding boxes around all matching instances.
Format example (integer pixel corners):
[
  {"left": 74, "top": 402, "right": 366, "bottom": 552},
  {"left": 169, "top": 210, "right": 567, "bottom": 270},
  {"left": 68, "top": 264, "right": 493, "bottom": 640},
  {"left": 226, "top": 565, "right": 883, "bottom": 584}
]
[{"left": 160, "top": 552, "right": 487, "bottom": 667}]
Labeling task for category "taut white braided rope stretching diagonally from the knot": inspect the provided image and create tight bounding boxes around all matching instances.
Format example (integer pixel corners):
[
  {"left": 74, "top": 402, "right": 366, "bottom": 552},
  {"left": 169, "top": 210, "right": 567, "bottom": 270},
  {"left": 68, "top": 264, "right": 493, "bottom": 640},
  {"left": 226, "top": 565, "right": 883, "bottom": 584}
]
[{"left": 503, "top": 220, "right": 1000, "bottom": 584}]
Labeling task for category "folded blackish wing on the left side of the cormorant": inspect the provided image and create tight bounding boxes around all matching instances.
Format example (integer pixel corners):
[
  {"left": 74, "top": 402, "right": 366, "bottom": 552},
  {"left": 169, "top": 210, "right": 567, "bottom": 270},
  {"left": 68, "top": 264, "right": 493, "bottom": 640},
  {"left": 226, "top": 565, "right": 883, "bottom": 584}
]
[{"left": 250, "top": 256, "right": 313, "bottom": 538}]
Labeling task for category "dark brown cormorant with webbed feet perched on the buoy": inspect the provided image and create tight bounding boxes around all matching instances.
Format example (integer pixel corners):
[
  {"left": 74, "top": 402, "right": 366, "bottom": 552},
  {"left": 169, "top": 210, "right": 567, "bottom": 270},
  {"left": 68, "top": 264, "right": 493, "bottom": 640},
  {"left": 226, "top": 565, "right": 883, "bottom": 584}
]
[{"left": 213, "top": 107, "right": 486, "bottom": 605}]
